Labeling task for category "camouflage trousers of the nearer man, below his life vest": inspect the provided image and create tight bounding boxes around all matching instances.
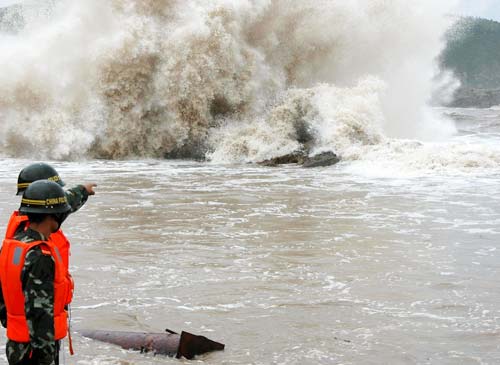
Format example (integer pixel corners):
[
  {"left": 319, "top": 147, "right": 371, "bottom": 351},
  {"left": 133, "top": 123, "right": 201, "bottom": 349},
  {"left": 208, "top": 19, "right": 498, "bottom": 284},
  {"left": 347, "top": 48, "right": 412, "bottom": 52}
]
[{"left": 5, "top": 340, "right": 57, "bottom": 365}]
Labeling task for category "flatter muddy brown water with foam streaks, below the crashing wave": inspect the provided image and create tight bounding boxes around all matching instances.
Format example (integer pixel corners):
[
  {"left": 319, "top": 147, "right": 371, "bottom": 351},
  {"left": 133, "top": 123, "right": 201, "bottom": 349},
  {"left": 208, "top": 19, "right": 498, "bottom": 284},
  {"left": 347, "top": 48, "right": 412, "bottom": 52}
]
[{"left": 0, "top": 110, "right": 500, "bottom": 365}]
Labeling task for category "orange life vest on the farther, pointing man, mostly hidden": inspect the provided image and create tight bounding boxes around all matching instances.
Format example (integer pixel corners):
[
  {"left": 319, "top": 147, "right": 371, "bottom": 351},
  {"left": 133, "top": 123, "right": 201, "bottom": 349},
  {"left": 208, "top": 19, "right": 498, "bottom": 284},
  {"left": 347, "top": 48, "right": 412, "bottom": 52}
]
[{"left": 5, "top": 210, "right": 75, "bottom": 304}]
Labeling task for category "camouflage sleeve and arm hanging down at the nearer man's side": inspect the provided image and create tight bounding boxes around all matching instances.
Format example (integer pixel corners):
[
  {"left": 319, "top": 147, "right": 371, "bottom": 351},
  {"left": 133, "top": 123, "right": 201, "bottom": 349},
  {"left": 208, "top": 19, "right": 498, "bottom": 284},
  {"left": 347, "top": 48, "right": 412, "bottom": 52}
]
[{"left": 21, "top": 247, "right": 55, "bottom": 358}]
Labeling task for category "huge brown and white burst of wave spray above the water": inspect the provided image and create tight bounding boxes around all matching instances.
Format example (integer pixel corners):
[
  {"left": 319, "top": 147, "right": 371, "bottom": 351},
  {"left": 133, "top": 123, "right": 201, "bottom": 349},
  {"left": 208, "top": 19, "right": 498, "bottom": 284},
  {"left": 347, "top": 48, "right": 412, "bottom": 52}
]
[{"left": 0, "top": 0, "right": 464, "bottom": 162}]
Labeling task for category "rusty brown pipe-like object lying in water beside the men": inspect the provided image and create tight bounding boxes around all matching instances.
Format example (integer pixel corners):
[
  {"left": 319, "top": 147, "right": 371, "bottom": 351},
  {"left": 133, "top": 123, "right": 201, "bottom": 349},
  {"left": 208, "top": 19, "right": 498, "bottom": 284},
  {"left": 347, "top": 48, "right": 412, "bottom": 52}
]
[{"left": 79, "top": 329, "right": 225, "bottom": 360}]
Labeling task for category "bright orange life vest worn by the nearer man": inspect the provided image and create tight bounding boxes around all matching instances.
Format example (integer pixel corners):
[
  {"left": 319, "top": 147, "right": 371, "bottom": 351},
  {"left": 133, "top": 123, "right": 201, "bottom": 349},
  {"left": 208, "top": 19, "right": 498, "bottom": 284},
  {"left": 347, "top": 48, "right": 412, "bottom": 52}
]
[{"left": 0, "top": 239, "right": 71, "bottom": 342}]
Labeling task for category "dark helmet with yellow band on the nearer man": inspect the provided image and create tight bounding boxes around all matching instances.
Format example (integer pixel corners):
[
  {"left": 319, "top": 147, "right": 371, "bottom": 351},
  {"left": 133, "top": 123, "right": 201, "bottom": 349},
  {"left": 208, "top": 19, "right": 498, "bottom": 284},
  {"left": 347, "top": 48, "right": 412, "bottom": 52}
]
[{"left": 19, "top": 180, "right": 71, "bottom": 214}]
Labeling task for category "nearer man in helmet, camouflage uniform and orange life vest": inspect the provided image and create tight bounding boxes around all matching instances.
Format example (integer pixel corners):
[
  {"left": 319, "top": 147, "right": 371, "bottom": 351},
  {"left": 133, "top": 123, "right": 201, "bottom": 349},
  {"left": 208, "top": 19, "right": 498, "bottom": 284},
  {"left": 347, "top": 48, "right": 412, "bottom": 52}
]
[{"left": 0, "top": 180, "right": 71, "bottom": 365}]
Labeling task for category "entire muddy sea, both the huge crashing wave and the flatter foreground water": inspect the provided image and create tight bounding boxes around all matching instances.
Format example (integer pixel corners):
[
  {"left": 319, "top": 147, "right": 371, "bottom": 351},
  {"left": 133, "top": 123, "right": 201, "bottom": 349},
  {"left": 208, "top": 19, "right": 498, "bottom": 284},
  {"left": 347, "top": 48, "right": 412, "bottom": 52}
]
[{"left": 0, "top": 0, "right": 500, "bottom": 365}]
